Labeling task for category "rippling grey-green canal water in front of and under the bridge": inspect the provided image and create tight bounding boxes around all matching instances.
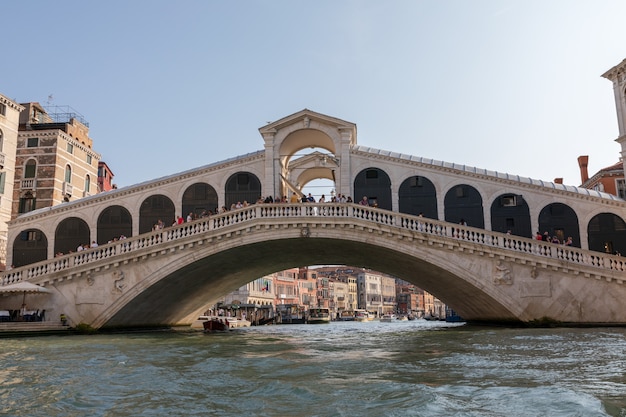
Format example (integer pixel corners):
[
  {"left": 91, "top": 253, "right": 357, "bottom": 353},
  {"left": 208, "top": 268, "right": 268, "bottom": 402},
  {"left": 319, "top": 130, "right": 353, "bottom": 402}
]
[{"left": 0, "top": 320, "right": 626, "bottom": 417}]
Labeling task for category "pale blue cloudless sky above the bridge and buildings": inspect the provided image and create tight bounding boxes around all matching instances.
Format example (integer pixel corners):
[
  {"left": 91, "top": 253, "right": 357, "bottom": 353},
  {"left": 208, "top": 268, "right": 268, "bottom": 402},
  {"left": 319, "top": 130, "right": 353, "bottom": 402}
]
[{"left": 0, "top": 0, "right": 626, "bottom": 187}]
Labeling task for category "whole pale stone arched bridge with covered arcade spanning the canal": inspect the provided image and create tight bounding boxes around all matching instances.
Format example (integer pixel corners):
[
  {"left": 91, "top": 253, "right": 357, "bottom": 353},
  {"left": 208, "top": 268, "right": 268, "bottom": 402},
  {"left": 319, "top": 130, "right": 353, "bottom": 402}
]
[{"left": 0, "top": 110, "right": 626, "bottom": 328}]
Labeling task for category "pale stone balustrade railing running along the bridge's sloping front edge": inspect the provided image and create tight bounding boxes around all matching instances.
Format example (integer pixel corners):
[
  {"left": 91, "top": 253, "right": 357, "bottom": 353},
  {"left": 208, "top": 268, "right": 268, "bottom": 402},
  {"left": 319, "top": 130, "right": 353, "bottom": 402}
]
[{"left": 0, "top": 203, "right": 626, "bottom": 285}]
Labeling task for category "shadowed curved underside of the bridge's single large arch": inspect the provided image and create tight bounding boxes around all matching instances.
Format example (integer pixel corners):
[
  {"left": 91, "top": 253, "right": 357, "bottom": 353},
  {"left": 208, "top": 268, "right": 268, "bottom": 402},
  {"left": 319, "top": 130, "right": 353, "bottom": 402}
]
[{"left": 93, "top": 231, "right": 520, "bottom": 327}]
